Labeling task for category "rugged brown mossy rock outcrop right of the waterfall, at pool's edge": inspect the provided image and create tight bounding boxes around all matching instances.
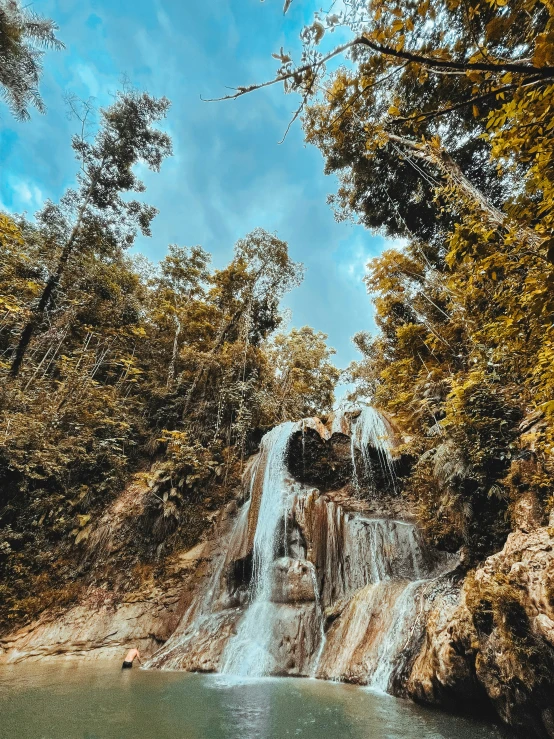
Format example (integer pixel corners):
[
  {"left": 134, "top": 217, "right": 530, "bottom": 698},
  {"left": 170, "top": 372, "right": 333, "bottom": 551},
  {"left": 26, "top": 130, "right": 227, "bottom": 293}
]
[{"left": 406, "top": 527, "right": 554, "bottom": 737}]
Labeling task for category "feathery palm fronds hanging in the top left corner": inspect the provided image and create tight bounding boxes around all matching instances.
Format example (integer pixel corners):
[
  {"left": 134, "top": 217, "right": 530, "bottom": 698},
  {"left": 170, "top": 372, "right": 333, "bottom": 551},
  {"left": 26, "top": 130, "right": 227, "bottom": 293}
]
[{"left": 0, "top": 0, "right": 64, "bottom": 121}]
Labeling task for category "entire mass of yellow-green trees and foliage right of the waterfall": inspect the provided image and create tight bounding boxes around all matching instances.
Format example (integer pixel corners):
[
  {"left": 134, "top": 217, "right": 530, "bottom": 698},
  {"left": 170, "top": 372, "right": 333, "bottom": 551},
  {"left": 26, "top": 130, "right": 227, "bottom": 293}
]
[{"left": 258, "top": 0, "right": 554, "bottom": 561}]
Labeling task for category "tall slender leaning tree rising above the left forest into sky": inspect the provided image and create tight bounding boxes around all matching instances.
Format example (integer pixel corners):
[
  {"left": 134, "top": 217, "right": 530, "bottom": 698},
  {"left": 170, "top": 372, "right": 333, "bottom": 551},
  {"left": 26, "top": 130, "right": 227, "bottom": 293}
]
[{"left": 11, "top": 90, "right": 171, "bottom": 377}]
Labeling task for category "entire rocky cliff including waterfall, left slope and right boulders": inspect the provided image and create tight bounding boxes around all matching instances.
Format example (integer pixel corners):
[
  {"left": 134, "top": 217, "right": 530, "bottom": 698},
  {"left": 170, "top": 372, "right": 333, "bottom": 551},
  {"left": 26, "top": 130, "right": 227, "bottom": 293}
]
[{"left": 0, "top": 408, "right": 554, "bottom": 737}]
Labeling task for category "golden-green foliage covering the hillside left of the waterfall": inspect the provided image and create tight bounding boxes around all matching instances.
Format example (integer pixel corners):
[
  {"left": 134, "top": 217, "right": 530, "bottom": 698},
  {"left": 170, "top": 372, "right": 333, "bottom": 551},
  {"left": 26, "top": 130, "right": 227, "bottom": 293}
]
[{"left": 0, "top": 201, "right": 337, "bottom": 627}]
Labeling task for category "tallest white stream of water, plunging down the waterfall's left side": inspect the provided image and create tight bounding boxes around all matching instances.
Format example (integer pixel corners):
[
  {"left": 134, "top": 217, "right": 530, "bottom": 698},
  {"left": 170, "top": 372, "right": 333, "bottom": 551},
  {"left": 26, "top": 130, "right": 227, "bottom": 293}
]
[{"left": 221, "top": 421, "right": 299, "bottom": 677}]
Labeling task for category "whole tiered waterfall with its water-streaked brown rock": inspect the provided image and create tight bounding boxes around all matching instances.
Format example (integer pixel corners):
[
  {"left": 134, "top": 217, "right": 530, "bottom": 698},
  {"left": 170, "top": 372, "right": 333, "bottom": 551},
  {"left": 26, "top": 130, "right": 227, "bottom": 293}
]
[{"left": 144, "top": 407, "right": 454, "bottom": 690}]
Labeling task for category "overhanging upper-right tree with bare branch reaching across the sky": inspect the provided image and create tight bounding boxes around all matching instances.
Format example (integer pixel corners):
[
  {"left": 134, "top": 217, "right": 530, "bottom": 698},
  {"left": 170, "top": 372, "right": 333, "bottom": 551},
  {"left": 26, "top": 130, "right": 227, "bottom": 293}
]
[{"left": 210, "top": 0, "right": 554, "bottom": 250}]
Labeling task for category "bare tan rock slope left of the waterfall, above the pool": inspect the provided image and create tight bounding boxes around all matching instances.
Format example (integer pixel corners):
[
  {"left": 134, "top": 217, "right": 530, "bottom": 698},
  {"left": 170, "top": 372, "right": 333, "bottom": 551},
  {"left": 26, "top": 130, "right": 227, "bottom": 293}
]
[{"left": 0, "top": 498, "right": 236, "bottom": 664}]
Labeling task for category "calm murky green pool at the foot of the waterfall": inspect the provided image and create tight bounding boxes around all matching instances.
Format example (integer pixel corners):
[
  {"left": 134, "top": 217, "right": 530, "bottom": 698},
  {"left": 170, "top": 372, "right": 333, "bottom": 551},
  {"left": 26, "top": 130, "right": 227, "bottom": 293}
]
[{"left": 0, "top": 664, "right": 500, "bottom": 739}]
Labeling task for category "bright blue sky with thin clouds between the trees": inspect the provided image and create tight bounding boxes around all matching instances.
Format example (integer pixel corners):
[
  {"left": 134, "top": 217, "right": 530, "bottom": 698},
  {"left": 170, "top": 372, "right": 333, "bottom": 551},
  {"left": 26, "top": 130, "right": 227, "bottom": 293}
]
[{"left": 0, "top": 0, "right": 392, "bottom": 367}]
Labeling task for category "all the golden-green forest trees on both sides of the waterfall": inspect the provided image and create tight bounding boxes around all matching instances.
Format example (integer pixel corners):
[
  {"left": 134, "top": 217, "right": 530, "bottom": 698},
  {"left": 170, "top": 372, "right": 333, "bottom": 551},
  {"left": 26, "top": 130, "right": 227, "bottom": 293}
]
[{"left": 0, "top": 0, "right": 554, "bottom": 728}]
